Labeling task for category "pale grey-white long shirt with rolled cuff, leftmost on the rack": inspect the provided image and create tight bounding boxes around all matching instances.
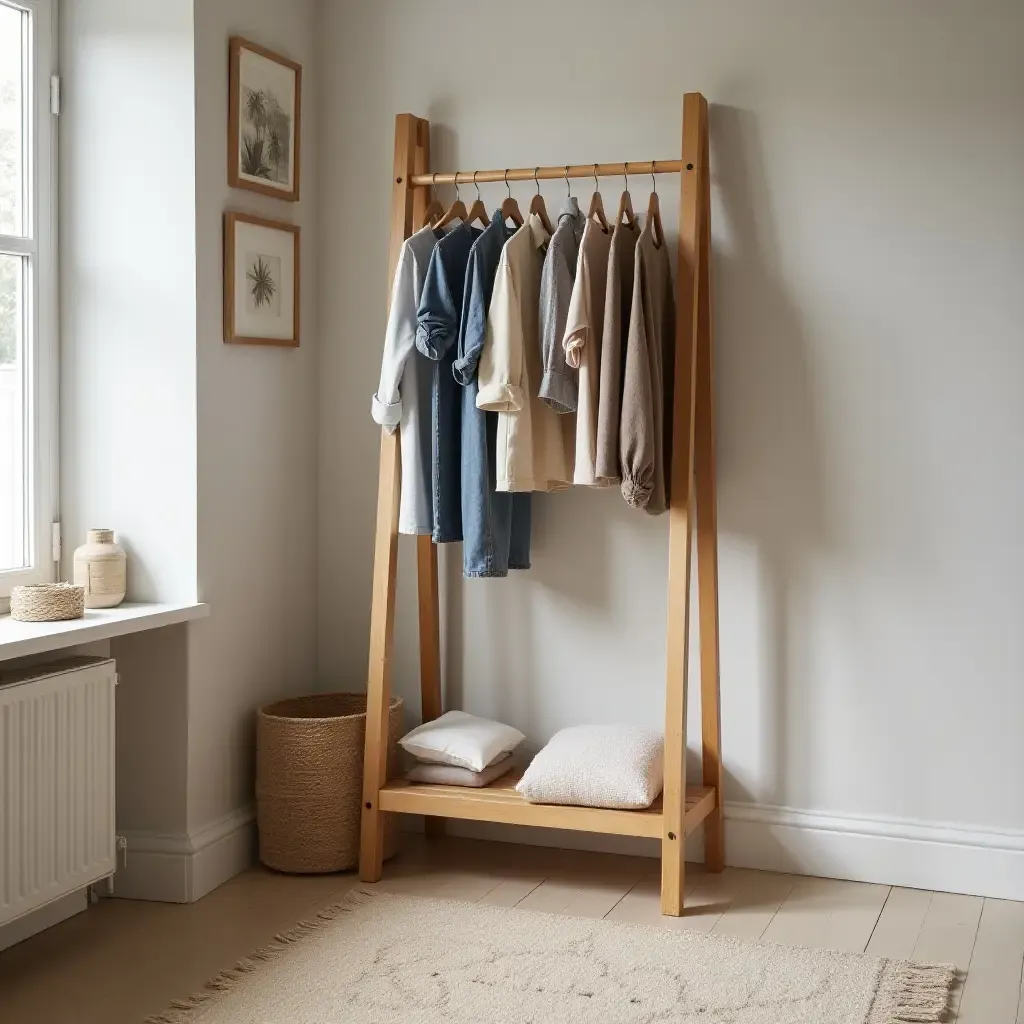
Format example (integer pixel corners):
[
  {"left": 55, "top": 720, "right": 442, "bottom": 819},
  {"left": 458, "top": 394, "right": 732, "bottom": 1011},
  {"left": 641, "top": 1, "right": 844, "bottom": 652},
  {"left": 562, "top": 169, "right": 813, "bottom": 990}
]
[{"left": 371, "top": 225, "right": 440, "bottom": 535}]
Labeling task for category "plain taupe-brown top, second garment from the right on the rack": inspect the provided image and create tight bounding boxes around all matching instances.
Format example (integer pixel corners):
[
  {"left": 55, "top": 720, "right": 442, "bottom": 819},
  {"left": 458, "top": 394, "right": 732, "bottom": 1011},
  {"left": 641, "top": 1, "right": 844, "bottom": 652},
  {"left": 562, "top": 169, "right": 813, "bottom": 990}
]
[{"left": 594, "top": 217, "right": 640, "bottom": 483}]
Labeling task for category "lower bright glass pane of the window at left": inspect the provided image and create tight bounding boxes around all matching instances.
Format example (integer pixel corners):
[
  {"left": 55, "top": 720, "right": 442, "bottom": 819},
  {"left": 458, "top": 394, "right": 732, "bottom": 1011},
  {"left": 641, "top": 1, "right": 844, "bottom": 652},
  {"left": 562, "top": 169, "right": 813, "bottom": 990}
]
[{"left": 0, "top": 255, "right": 29, "bottom": 571}]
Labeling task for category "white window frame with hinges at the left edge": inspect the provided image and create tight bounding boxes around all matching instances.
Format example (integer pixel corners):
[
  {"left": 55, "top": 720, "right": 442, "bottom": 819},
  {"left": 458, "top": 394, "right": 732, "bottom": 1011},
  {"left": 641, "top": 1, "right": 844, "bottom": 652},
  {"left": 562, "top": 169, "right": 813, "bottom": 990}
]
[{"left": 0, "top": 0, "right": 58, "bottom": 598}]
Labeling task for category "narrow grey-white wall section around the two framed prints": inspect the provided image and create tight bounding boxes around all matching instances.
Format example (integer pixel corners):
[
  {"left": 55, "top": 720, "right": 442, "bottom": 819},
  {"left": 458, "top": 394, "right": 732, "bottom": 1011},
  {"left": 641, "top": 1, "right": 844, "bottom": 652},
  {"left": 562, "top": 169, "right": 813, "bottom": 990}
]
[{"left": 188, "top": 0, "right": 318, "bottom": 833}]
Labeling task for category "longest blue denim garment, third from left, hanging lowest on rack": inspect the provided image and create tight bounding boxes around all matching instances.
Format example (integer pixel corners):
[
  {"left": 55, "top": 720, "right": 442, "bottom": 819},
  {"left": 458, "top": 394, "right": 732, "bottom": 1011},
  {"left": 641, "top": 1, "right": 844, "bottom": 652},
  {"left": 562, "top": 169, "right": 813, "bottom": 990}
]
[{"left": 454, "top": 211, "right": 532, "bottom": 578}]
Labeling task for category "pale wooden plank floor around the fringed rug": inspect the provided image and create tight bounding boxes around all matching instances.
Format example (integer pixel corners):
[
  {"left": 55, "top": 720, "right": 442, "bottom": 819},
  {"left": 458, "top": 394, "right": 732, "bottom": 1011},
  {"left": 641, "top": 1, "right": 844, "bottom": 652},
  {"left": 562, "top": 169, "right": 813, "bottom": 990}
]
[{"left": 0, "top": 837, "right": 1024, "bottom": 1024}]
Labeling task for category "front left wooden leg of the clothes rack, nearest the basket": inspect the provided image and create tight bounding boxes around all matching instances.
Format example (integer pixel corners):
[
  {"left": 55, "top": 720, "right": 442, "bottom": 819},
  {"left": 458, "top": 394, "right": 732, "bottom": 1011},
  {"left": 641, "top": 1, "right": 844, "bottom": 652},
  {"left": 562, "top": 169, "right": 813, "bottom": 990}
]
[{"left": 359, "top": 114, "right": 425, "bottom": 882}]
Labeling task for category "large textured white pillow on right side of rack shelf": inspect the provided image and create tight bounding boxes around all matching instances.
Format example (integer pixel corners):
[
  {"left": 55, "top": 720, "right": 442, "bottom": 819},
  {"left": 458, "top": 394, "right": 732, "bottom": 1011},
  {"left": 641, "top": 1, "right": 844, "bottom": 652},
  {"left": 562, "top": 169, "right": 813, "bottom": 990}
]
[{"left": 516, "top": 725, "right": 665, "bottom": 810}]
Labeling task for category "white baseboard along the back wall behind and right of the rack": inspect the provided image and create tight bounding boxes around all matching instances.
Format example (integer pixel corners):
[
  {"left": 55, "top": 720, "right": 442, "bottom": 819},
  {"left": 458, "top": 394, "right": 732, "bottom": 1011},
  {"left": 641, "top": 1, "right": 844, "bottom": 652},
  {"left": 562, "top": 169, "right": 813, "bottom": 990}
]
[{"left": 397, "top": 803, "right": 1024, "bottom": 900}]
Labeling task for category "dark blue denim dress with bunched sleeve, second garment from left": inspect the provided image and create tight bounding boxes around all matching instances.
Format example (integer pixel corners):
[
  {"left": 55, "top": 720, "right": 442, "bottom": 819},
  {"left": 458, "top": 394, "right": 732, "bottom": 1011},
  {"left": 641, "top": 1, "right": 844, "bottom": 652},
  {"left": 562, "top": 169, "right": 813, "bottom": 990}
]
[{"left": 416, "top": 221, "right": 483, "bottom": 544}]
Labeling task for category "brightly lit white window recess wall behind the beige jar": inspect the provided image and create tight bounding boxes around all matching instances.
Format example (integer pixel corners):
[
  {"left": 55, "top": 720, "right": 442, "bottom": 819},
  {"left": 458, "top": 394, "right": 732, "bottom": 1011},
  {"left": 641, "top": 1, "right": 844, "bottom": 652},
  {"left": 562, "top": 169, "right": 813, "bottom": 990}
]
[{"left": 59, "top": 0, "right": 197, "bottom": 601}]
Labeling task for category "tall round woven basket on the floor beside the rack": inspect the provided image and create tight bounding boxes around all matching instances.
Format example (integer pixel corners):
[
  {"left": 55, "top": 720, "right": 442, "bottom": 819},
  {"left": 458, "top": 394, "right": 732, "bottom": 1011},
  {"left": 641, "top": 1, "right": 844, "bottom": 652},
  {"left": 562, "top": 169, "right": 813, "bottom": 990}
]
[{"left": 256, "top": 693, "right": 402, "bottom": 874}]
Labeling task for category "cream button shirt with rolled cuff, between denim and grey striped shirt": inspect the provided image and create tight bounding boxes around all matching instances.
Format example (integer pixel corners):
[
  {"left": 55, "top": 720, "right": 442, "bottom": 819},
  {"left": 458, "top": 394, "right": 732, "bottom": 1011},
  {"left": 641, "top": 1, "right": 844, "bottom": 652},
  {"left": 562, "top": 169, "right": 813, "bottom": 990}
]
[{"left": 476, "top": 213, "right": 569, "bottom": 490}]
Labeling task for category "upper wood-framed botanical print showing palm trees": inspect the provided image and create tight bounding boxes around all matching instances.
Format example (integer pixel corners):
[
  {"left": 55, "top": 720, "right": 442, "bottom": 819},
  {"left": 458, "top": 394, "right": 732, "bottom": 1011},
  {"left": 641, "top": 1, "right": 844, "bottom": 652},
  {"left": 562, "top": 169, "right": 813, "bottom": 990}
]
[{"left": 227, "top": 36, "right": 302, "bottom": 202}]
